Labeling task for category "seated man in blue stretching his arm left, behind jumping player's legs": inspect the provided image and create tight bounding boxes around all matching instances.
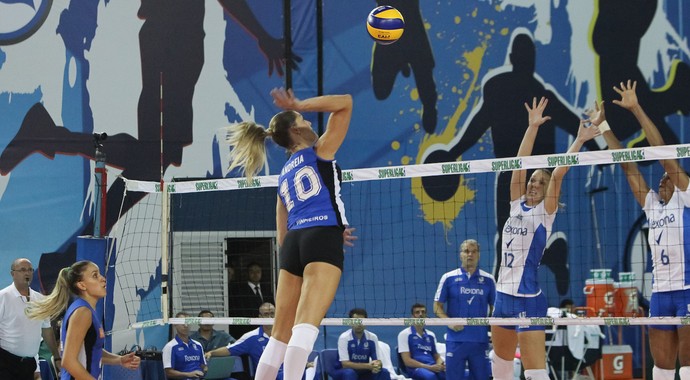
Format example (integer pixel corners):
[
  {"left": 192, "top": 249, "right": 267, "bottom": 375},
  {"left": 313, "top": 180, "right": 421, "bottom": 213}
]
[{"left": 206, "top": 302, "right": 283, "bottom": 380}]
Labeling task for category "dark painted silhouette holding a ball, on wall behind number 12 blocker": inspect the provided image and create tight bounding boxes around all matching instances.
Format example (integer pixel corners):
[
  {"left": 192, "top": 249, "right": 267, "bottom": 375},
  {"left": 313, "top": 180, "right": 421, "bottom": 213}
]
[{"left": 422, "top": 33, "right": 598, "bottom": 294}]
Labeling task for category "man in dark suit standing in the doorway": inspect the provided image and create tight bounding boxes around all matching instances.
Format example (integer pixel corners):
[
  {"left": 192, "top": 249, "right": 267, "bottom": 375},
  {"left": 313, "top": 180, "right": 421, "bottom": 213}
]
[{"left": 229, "top": 262, "right": 274, "bottom": 336}]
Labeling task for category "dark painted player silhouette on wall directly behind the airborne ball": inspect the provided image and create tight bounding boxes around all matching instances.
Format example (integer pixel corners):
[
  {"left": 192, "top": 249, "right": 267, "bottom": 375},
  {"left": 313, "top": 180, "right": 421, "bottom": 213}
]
[{"left": 371, "top": 0, "right": 438, "bottom": 134}]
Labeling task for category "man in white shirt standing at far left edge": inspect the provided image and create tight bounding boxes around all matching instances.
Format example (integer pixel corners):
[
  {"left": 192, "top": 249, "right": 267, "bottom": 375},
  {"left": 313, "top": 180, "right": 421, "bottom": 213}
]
[{"left": 0, "top": 258, "right": 60, "bottom": 380}]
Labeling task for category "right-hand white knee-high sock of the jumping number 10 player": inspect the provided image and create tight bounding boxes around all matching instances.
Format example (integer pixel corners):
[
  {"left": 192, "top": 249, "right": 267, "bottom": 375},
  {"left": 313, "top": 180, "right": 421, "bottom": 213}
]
[{"left": 282, "top": 323, "right": 319, "bottom": 380}]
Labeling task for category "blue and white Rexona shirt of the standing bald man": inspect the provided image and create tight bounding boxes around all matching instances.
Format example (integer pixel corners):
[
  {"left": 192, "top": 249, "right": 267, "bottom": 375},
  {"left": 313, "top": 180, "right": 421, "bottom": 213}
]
[{"left": 434, "top": 268, "right": 496, "bottom": 342}]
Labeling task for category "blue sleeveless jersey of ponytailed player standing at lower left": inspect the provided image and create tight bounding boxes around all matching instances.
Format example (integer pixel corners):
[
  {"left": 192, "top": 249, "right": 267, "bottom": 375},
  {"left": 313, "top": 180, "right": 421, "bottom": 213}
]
[{"left": 60, "top": 298, "right": 105, "bottom": 380}]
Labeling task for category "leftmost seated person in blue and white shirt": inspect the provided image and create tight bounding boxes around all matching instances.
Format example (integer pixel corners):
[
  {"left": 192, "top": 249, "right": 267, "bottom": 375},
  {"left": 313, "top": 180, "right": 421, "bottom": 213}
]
[{"left": 163, "top": 312, "right": 208, "bottom": 379}]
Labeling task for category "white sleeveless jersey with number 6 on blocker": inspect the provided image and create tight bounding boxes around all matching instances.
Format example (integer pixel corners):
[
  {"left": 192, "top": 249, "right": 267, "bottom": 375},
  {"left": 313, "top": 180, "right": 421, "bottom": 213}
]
[{"left": 643, "top": 187, "right": 690, "bottom": 292}]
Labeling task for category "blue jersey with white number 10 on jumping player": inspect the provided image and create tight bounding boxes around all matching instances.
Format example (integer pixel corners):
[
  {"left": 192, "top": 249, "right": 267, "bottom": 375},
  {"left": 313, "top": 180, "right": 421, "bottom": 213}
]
[{"left": 278, "top": 148, "right": 348, "bottom": 230}]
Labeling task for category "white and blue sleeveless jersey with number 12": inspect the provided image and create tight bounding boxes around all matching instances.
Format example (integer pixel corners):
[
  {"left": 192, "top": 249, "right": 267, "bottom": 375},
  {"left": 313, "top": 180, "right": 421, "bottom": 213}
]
[{"left": 496, "top": 196, "right": 556, "bottom": 297}]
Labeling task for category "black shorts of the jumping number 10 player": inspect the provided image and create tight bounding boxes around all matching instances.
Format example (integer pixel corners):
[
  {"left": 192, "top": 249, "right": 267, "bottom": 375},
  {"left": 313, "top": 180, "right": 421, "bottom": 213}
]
[{"left": 280, "top": 226, "right": 345, "bottom": 277}]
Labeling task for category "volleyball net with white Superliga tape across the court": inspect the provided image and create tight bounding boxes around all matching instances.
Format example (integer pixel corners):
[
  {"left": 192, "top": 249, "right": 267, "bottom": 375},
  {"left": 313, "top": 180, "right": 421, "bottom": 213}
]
[{"left": 106, "top": 144, "right": 690, "bottom": 330}]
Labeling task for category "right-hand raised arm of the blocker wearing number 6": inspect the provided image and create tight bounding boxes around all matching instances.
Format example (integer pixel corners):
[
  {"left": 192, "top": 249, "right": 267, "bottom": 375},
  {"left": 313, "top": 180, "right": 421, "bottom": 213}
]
[{"left": 613, "top": 80, "right": 690, "bottom": 191}]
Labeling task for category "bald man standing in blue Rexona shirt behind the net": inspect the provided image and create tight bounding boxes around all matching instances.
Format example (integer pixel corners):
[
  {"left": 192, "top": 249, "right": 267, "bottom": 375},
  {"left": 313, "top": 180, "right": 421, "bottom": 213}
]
[{"left": 434, "top": 239, "right": 496, "bottom": 380}]
